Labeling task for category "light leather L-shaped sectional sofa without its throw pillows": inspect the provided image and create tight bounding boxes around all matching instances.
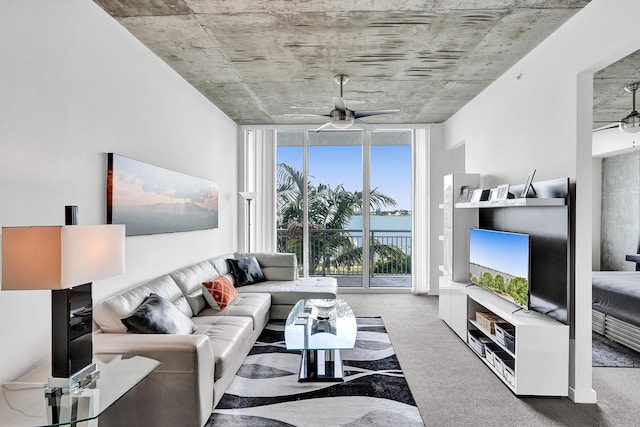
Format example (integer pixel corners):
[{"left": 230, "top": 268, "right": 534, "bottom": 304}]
[{"left": 93, "top": 253, "right": 337, "bottom": 427}]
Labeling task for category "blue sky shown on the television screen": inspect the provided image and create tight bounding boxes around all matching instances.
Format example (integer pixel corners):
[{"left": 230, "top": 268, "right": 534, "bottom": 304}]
[{"left": 469, "top": 228, "right": 529, "bottom": 278}]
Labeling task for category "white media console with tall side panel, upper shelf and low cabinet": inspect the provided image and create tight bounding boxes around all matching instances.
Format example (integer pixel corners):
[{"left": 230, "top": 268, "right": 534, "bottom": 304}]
[{"left": 439, "top": 174, "right": 569, "bottom": 396}]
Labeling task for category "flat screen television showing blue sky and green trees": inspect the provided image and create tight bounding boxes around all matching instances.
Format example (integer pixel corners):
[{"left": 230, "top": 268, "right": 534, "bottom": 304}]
[{"left": 469, "top": 228, "right": 530, "bottom": 309}]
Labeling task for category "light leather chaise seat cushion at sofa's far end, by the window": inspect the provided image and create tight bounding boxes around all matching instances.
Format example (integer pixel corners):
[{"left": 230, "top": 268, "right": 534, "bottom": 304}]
[{"left": 238, "top": 277, "right": 338, "bottom": 305}]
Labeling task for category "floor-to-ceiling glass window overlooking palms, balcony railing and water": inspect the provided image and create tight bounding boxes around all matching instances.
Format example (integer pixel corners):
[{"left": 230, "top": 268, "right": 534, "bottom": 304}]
[{"left": 276, "top": 129, "right": 413, "bottom": 288}]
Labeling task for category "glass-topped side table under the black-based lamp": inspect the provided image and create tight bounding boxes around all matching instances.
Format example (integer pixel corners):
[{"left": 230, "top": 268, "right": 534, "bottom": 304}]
[{"left": 0, "top": 355, "right": 160, "bottom": 427}]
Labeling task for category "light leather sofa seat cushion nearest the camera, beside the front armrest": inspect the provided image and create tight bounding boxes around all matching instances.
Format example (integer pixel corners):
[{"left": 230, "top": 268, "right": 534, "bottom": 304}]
[{"left": 192, "top": 316, "right": 253, "bottom": 381}]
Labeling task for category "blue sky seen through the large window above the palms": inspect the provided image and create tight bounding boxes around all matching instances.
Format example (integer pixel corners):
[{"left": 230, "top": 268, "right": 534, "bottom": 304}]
[{"left": 277, "top": 145, "right": 411, "bottom": 210}]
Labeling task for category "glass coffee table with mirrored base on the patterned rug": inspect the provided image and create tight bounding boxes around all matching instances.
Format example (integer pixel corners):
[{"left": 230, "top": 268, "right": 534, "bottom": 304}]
[{"left": 284, "top": 299, "right": 358, "bottom": 381}]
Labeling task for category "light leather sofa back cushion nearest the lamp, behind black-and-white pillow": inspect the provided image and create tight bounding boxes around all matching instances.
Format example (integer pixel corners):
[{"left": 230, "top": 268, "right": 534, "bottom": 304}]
[{"left": 93, "top": 274, "right": 193, "bottom": 333}]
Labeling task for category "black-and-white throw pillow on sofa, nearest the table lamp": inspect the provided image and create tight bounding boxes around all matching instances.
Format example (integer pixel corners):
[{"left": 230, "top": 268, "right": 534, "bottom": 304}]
[{"left": 122, "top": 294, "right": 196, "bottom": 335}]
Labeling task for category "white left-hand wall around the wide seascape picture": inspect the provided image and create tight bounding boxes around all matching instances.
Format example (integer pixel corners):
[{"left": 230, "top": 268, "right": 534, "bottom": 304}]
[{"left": 0, "top": 0, "right": 237, "bottom": 383}]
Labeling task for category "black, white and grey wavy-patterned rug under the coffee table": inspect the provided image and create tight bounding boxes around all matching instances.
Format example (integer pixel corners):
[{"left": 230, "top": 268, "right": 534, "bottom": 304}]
[{"left": 207, "top": 317, "right": 424, "bottom": 427}]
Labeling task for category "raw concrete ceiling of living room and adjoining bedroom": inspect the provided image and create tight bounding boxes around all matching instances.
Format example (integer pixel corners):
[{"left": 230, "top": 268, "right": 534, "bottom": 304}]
[{"left": 95, "top": 0, "right": 640, "bottom": 129}]
